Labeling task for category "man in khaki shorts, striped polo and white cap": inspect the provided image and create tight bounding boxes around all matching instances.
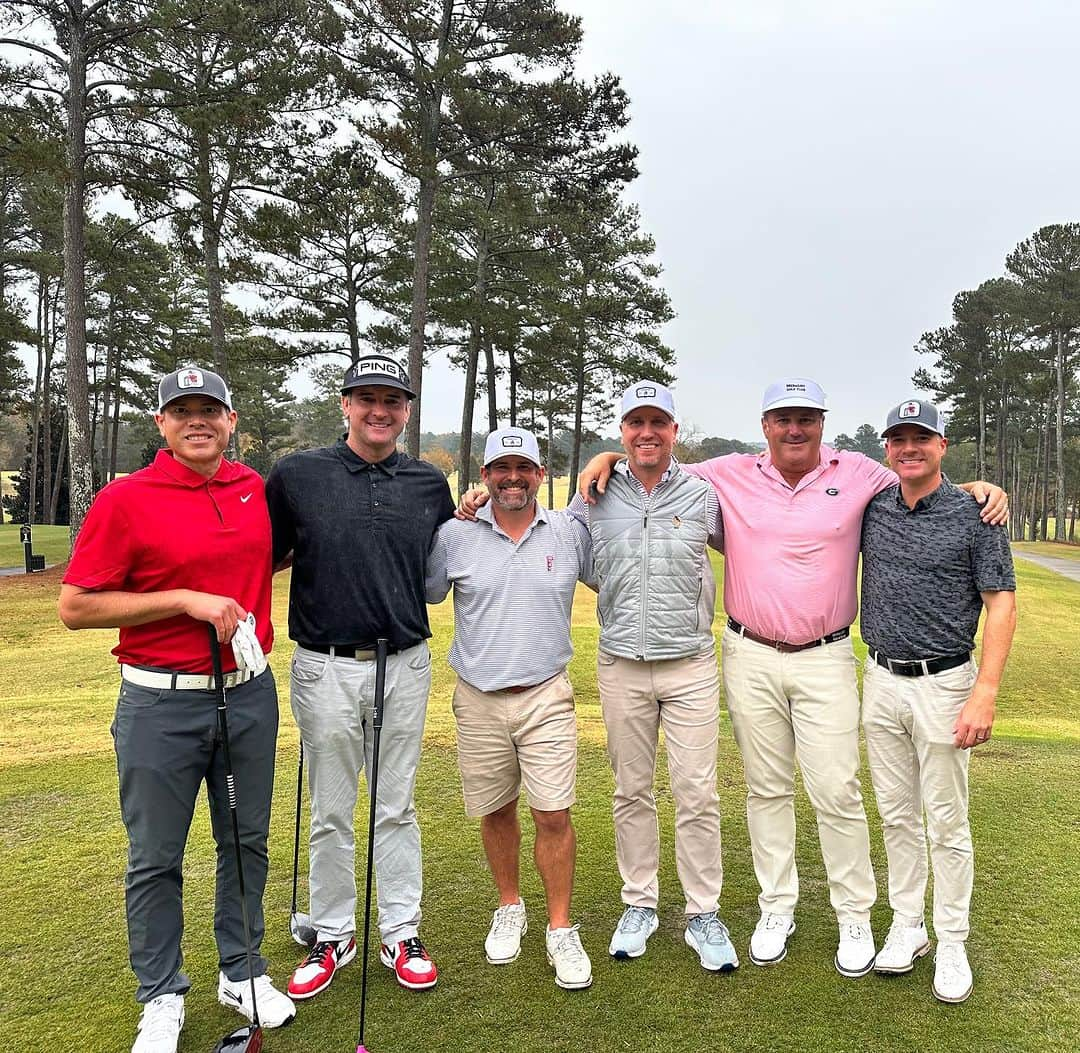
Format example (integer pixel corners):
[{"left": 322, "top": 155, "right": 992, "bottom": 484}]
[{"left": 427, "top": 428, "right": 593, "bottom": 989}]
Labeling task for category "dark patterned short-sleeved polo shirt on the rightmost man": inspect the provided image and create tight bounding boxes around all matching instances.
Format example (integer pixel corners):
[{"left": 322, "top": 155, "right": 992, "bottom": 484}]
[{"left": 859, "top": 480, "right": 1016, "bottom": 661}]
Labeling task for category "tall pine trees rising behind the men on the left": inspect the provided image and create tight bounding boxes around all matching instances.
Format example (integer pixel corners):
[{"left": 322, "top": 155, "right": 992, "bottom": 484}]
[{"left": 0, "top": 0, "right": 674, "bottom": 532}]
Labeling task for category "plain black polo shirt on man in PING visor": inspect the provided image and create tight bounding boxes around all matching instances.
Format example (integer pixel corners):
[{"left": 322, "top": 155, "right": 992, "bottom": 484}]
[{"left": 267, "top": 440, "right": 454, "bottom": 650}]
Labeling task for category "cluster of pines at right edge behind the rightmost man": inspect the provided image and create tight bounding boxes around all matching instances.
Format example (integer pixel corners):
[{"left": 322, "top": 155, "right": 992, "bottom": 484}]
[{"left": 914, "top": 224, "right": 1080, "bottom": 541}]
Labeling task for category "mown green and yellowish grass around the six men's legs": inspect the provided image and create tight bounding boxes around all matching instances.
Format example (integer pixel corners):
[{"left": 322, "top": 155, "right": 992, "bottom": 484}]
[{"left": 0, "top": 564, "right": 1080, "bottom": 1053}]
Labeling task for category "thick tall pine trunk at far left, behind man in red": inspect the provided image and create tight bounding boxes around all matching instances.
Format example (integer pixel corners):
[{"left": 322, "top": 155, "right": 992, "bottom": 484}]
[{"left": 62, "top": 8, "right": 94, "bottom": 545}]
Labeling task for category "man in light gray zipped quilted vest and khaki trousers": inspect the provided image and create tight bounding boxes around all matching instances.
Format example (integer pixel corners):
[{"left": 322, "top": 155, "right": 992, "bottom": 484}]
[{"left": 570, "top": 380, "right": 739, "bottom": 972}]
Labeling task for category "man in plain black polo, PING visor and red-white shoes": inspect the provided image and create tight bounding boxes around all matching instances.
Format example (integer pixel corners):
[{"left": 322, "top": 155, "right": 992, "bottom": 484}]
[{"left": 267, "top": 354, "right": 454, "bottom": 999}]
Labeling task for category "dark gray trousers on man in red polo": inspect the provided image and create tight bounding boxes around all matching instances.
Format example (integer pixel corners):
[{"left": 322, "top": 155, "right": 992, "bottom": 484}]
[{"left": 112, "top": 670, "right": 278, "bottom": 1002}]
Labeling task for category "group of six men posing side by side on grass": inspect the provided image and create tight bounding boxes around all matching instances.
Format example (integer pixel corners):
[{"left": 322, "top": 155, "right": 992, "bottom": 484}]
[{"left": 59, "top": 355, "right": 1015, "bottom": 1053}]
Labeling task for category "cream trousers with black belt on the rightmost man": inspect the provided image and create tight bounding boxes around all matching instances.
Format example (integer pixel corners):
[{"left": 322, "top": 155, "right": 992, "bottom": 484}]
[{"left": 863, "top": 660, "right": 977, "bottom": 942}]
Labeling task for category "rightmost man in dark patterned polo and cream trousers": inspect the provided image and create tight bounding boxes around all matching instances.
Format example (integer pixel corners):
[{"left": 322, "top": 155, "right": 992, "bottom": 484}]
[{"left": 862, "top": 399, "right": 1016, "bottom": 1002}]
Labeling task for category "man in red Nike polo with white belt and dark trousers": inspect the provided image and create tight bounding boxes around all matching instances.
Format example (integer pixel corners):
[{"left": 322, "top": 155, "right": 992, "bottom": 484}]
[{"left": 59, "top": 367, "right": 296, "bottom": 1053}]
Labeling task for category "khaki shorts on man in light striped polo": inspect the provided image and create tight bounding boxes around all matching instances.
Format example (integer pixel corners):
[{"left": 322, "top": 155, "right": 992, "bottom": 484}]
[{"left": 454, "top": 671, "right": 578, "bottom": 818}]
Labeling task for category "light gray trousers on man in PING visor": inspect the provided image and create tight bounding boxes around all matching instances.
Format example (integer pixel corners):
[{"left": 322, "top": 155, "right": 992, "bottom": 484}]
[{"left": 292, "top": 643, "right": 431, "bottom": 944}]
